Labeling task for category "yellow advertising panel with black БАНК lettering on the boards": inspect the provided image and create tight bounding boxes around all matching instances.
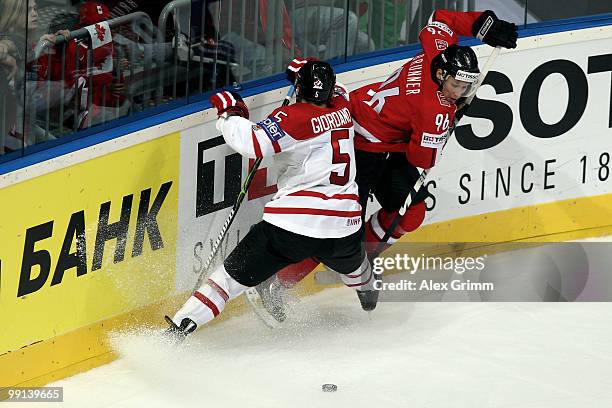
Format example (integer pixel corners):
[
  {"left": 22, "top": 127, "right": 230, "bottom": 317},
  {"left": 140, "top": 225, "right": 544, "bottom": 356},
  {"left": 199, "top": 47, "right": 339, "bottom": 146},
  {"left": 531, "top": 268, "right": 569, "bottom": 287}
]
[{"left": 0, "top": 133, "right": 179, "bottom": 385}]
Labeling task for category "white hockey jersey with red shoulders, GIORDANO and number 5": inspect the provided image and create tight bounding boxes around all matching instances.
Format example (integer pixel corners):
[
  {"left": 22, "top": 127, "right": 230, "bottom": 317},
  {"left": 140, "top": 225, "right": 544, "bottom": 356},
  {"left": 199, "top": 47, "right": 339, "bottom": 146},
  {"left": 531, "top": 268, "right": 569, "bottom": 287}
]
[{"left": 217, "top": 96, "right": 361, "bottom": 238}]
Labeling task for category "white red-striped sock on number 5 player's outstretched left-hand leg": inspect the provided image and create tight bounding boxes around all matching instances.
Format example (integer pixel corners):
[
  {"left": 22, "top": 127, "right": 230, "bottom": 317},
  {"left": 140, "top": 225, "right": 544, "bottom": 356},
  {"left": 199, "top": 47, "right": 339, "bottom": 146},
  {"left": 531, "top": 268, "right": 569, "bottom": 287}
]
[{"left": 172, "top": 265, "right": 248, "bottom": 326}]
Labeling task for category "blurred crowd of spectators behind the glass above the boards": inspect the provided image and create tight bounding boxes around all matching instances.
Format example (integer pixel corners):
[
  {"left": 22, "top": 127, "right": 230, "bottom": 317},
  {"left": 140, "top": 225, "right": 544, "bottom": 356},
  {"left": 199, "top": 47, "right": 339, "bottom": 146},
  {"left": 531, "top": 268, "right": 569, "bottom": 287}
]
[{"left": 0, "top": 0, "right": 612, "bottom": 162}]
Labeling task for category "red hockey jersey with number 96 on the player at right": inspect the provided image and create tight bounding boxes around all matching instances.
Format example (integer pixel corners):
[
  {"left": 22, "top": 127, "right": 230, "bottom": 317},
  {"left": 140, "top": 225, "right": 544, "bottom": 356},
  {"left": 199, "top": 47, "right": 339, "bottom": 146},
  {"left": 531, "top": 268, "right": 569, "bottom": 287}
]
[{"left": 350, "top": 10, "right": 481, "bottom": 169}]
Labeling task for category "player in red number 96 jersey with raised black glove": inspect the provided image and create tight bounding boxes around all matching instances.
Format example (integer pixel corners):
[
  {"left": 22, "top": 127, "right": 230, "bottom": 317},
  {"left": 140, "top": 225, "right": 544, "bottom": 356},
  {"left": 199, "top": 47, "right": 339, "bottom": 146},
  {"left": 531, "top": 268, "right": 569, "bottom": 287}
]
[{"left": 351, "top": 10, "right": 518, "bottom": 249}]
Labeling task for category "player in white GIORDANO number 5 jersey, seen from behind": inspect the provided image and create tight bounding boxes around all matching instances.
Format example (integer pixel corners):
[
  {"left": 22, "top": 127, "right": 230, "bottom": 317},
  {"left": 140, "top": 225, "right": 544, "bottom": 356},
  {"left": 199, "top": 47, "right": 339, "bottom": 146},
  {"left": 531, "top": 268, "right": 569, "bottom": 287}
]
[{"left": 169, "top": 61, "right": 376, "bottom": 337}]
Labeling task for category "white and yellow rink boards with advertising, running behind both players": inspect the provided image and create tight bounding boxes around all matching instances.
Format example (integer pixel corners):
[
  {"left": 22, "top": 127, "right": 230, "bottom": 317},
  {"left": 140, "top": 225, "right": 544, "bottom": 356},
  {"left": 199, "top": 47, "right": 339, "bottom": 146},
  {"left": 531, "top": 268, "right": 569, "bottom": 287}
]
[{"left": 0, "top": 20, "right": 612, "bottom": 387}]
